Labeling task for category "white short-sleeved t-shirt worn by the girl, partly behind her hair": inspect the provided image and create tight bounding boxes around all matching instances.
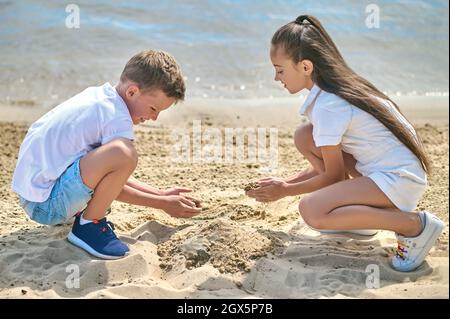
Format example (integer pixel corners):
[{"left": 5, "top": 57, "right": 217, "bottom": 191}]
[{"left": 300, "top": 85, "right": 427, "bottom": 184}]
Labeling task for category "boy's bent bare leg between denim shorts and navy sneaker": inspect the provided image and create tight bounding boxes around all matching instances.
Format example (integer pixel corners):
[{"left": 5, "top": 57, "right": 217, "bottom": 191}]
[{"left": 80, "top": 138, "right": 138, "bottom": 220}]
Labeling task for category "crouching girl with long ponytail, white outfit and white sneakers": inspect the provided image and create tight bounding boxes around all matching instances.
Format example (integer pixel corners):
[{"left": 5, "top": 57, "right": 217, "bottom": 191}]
[{"left": 246, "top": 15, "right": 444, "bottom": 271}]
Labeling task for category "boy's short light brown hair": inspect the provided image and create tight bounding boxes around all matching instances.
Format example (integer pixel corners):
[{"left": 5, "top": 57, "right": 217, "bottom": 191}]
[{"left": 120, "top": 50, "right": 186, "bottom": 101}]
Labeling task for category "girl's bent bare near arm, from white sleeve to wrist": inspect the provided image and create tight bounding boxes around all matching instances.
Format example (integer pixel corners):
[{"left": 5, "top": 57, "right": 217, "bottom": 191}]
[{"left": 285, "top": 145, "right": 345, "bottom": 196}]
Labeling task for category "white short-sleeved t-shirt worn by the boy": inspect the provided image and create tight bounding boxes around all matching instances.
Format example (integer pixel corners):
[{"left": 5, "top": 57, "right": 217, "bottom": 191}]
[{"left": 12, "top": 83, "right": 134, "bottom": 202}]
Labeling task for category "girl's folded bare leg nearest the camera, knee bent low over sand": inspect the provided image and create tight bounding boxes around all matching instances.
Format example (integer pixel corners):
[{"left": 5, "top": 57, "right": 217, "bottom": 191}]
[{"left": 299, "top": 177, "right": 422, "bottom": 237}]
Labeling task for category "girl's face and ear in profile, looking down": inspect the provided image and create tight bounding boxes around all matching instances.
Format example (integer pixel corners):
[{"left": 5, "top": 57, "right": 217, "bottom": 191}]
[{"left": 270, "top": 47, "right": 314, "bottom": 94}]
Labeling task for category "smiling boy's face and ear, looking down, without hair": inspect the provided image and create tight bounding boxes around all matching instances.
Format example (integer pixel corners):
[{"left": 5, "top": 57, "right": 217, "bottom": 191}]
[{"left": 125, "top": 85, "right": 175, "bottom": 124}]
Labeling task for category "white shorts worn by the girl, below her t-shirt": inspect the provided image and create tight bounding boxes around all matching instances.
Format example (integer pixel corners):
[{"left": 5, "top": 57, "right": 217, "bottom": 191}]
[{"left": 367, "top": 172, "right": 427, "bottom": 212}]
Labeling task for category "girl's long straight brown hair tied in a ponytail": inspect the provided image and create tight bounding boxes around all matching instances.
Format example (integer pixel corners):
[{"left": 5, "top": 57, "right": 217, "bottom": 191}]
[{"left": 272, "top": 15, "right": 431, "bottom": 174}]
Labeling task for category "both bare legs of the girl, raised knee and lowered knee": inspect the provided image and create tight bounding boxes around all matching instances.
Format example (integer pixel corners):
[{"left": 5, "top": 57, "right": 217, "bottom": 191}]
[{"left": 294, "top": 123, "right": 421, "bottom": 236}]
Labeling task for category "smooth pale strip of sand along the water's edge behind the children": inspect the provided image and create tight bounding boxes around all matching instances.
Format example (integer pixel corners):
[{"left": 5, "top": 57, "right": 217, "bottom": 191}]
[{"left": 0, "top": 96, "right": 449, "bottom": 126}]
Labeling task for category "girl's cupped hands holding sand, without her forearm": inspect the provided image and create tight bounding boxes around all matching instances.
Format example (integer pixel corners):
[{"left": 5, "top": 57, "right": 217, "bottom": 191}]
[{"left": 245, "top": 177, "right": 287, "bottom": 202}]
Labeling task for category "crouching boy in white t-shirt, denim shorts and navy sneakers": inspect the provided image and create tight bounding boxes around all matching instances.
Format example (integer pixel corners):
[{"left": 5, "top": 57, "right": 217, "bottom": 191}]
[{"left": 12, "top": 50, "right": 200, "bottom": 259}]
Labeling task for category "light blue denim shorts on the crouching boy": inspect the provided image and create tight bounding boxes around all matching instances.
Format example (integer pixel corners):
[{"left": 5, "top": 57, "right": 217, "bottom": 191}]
[{"left": 19, "top": 159, "right": 94, "bottom": 225}]
